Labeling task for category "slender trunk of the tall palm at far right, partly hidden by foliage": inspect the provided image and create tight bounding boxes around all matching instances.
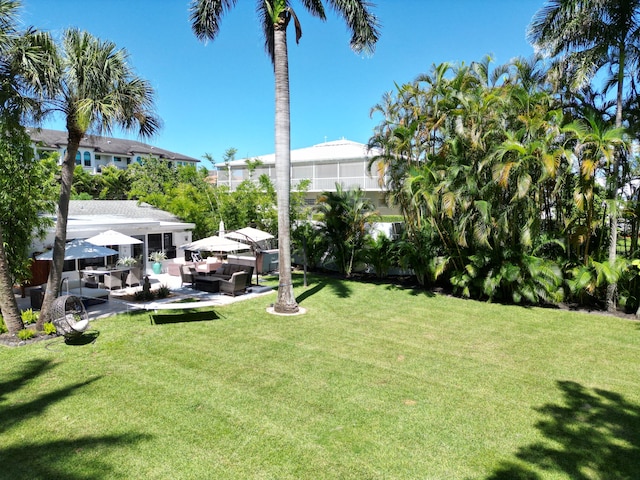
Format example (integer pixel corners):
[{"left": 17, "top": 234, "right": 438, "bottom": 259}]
[{"left": 607, "top": 41, "right": 626, "bottom": 312}]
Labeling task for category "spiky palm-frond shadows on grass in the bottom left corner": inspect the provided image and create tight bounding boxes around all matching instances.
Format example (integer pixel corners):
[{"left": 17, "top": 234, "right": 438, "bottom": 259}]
[{"left": 0, "top": 360, "right": 150, "bottom": 480}]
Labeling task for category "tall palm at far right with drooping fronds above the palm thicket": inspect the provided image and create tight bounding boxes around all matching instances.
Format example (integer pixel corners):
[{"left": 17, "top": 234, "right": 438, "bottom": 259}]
[{"left": 528, "top": 0, "right": 640, "bottom": 311}]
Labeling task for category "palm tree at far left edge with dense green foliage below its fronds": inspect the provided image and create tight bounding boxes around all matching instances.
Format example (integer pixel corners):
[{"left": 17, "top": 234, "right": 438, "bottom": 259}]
[{"left": 0, "top": 0, "right": 57, "bottom": 333}]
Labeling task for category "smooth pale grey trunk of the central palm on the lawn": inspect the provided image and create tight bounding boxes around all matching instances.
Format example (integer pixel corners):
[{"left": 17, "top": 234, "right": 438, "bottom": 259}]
[{"left": 273, "top": 18, "right": 298, "bottom": 313}]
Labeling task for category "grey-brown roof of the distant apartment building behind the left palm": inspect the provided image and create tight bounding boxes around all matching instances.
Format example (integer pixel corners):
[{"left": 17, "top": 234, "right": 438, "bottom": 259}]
[{"left": 28, "top": 128, "right": 200, "bottom": 162}]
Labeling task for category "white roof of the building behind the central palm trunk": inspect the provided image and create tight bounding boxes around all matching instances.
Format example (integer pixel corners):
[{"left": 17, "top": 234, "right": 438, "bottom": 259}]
[{"left": 216, "top": 139, "right": 379, "bottom": 167}]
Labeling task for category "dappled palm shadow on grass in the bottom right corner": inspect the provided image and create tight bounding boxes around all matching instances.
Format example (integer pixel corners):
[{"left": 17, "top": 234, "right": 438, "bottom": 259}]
[{"left": 488, "top": 382, "right": 640, "bottom": 480}]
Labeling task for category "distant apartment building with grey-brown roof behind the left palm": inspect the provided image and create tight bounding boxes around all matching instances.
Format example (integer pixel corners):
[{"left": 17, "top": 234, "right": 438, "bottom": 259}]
[{"left": 28, "top": 128, "right": 200, "bottom": 174}]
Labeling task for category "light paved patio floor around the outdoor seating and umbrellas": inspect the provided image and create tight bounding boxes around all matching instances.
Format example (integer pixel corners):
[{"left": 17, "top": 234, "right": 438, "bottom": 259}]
[{"left": 16, "top": 273, "right": 275, "bottom": 319}]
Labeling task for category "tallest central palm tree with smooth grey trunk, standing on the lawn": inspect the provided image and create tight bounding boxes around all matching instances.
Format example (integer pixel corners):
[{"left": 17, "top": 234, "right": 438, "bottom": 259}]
[{"left": 190, "top": 0, "right": 378, "bottom": 313}]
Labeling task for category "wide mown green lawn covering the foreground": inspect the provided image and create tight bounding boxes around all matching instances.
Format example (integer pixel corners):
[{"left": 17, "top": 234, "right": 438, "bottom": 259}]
[{"left": 0, "top": 275, "right": 640, "bottom": 480}]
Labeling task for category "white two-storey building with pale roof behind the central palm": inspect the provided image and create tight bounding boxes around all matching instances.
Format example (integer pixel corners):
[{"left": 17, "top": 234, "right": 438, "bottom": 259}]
[{"left": 215, "top": 139, "right": 398, "bottom": 215}]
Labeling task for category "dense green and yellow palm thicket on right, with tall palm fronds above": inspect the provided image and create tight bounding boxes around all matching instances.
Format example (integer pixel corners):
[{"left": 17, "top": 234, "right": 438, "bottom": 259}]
[{"left": 369, "top": 7, "right": 640, "bottom": 308}]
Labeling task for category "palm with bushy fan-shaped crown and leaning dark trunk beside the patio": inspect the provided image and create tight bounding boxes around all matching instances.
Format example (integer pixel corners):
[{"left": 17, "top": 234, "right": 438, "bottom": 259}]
[{"left": 37, "top": 29, "right": 160, "bottom": 328}]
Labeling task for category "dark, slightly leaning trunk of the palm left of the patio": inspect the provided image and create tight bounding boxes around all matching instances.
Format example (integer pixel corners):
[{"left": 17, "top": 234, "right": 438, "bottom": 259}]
[{"left": 36, "top": 126, "right": 84, "bottom": 330}]
